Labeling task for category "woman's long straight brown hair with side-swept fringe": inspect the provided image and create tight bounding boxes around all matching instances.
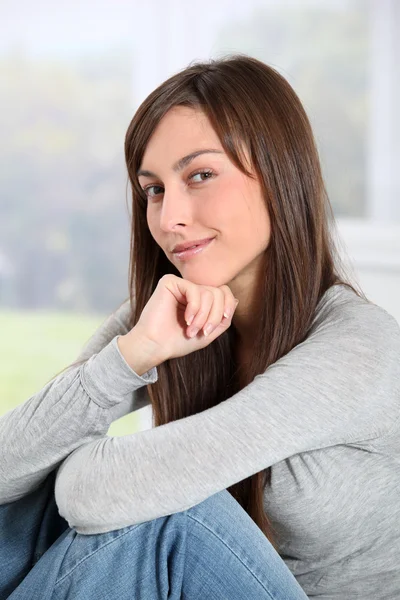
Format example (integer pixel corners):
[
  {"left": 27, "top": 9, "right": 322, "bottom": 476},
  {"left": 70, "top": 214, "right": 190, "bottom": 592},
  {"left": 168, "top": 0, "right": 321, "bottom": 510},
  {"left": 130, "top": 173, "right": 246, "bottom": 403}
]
[{"left": 53, "top": 54, "right": 363, "bottom": 547}]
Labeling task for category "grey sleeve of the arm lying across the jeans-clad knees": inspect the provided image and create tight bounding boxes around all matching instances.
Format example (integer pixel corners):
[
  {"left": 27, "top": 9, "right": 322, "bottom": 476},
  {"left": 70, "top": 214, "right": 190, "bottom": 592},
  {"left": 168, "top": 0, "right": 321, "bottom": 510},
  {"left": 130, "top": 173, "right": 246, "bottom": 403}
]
[{"left": 55, "top": 296, "right": 400, "bottom": 534}]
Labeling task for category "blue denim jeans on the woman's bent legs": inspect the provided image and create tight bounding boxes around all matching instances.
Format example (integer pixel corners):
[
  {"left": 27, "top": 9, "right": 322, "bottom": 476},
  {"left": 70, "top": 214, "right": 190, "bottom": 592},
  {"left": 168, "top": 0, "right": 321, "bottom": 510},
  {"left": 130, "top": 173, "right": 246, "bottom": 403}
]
[{"left": 0, "top": 473, "right": 307, "bottom": 600}]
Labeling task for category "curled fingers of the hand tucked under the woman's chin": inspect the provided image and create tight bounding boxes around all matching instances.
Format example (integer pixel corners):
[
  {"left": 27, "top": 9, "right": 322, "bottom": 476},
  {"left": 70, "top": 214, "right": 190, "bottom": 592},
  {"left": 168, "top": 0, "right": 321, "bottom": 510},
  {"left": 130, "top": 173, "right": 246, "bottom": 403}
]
[{"left": 185, "top": 284, "right": 238, "bottom": 337}]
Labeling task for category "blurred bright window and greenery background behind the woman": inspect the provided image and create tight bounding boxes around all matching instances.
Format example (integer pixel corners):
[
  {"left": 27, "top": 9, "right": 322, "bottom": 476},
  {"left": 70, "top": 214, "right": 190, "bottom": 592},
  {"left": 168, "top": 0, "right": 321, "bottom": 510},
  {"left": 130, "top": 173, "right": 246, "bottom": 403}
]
[{"left": 0, "top": 0, "right": 400, "bottom": 435}]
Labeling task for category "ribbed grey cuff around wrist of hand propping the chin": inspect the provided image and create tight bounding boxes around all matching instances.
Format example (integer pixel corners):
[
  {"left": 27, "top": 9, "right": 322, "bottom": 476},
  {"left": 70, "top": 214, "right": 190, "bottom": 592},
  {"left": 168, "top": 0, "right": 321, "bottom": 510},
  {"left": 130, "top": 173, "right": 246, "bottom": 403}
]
[{"left": 80, "top": 335, "right": 158, "bottom": 408}]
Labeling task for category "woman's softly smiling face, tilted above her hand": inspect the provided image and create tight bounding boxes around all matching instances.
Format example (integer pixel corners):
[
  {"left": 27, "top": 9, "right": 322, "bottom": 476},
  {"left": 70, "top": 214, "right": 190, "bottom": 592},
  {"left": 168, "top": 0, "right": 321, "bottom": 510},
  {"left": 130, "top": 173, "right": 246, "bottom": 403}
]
[{"left": 138, "top": 106, "right": 270, "bottom": 297}]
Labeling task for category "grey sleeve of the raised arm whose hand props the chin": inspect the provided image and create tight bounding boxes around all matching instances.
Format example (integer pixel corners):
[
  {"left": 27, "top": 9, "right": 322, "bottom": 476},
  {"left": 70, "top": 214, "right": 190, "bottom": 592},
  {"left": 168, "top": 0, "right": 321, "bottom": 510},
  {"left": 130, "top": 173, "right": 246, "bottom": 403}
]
[{"left": 0, "top": 302, "right": 157, "bottom": 504}]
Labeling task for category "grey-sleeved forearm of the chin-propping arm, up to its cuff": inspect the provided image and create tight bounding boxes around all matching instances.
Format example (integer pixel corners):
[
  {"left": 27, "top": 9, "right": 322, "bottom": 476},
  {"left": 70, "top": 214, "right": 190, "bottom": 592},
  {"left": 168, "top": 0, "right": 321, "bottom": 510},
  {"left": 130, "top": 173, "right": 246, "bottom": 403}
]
[{"left": 0, "top": 366, "right": 109, "bottom": 504}]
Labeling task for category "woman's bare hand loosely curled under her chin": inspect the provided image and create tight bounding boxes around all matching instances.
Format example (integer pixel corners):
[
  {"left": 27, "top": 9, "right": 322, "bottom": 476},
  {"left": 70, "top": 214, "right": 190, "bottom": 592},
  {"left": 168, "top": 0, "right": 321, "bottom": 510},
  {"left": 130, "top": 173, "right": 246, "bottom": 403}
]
[{"left": 126, "top": 274, "right": 239, "bottom": 361}]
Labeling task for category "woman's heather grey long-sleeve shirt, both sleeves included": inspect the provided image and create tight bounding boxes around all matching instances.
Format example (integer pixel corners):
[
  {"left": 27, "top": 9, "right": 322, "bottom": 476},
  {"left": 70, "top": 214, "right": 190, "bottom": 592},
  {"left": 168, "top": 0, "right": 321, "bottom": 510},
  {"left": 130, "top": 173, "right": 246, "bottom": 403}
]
[{"left": 0, "top": 285, "right": 400, "bottom": 600}]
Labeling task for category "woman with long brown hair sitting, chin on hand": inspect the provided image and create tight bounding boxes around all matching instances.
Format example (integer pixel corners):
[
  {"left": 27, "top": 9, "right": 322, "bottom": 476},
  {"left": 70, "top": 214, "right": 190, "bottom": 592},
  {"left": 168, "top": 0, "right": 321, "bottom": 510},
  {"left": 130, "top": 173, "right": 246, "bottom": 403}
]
[{"left": 0, "top": 55, "right": 400, "bottom": 600}]
